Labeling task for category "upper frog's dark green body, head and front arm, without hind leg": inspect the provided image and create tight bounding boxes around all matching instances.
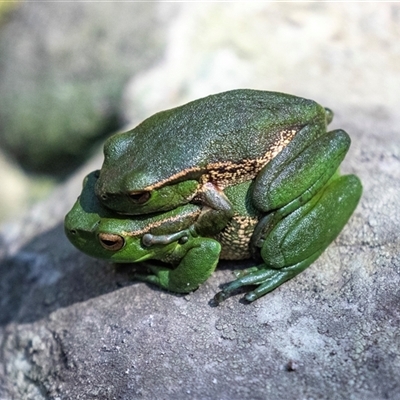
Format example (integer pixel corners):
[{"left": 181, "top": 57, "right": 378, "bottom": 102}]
[{"left": 95, "top": 89, "right": 332, "bottom": 233}]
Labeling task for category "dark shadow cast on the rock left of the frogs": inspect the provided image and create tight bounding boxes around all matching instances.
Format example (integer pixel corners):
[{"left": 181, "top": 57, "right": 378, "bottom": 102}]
[{"left": 0, "top": 223, "right": 150, "bottom": 325}]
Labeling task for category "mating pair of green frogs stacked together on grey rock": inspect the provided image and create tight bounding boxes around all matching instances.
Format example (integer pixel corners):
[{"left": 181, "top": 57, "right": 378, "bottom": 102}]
[{"left": 65, "top": 90, "right": 362, "bottom": 302}]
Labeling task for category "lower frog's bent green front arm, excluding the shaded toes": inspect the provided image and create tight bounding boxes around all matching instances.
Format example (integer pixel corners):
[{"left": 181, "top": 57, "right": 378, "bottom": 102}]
[{"left": 160, "top": 238, "right": 221, "bottom": 293}]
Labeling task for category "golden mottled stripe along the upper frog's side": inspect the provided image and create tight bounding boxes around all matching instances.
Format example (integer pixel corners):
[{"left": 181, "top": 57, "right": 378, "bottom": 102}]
[{"left": 143, "top": 129, "right": 299, "bottom": 191}]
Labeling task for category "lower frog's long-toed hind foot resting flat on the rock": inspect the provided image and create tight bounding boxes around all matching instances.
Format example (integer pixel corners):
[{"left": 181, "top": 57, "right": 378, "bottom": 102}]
[{"left": 214, "top": 260, "right": 310, "bottom": 303}]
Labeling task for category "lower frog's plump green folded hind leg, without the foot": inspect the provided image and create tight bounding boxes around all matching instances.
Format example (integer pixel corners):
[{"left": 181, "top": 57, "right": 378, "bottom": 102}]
[{"left": 261, "top": 175, "right": 362, "bottom": 270}]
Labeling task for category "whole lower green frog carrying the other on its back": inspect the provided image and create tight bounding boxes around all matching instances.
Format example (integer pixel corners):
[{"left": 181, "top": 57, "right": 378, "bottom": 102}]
[{"left": 65, "top": 172, "right": 362, "bottom": 303}]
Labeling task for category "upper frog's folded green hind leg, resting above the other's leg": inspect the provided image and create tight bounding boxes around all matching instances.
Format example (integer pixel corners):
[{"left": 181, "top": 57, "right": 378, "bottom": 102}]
[{"left": 253, "top": 130, "right": 350, "bottom": 212}]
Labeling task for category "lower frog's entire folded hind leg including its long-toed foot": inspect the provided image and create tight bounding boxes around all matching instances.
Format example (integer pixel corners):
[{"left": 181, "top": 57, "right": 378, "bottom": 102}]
[{"left": 215, "top": 175, "right": 362, "bottom": 302}]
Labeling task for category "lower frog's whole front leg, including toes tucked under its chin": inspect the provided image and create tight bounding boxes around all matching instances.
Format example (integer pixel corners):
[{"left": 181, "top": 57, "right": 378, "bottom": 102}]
[{"left": 134, "top": 237, "right": 221, "bottom": 293}]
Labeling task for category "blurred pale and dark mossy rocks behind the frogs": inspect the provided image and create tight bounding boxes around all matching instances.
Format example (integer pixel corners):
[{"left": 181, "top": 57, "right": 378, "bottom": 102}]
[{"left": 0, "top": 1, "right": 400, "bottom": 222}]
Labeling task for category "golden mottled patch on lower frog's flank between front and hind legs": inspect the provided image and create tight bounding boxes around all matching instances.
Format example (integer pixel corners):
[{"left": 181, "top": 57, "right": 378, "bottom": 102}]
[{"left": 214, "top": 215, "right": 258, "bottom": 260}]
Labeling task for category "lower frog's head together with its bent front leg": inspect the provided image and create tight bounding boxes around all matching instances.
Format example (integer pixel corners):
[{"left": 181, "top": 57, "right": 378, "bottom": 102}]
[{"left": 64, "top": 171, "right": 221, "bottom": 293}]
